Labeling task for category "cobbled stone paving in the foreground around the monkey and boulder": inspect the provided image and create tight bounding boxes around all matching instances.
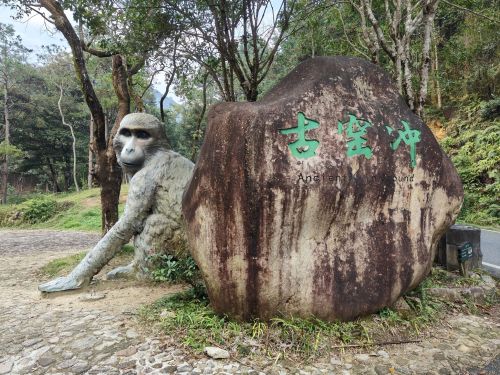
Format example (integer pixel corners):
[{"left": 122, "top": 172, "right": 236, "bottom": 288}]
[{"left": 0, "top": 230, "right": 500, "bottom": 375}]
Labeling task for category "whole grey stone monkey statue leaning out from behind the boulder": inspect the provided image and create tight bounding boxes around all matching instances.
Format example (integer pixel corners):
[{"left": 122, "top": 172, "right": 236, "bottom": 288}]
[{"left": 38, "top": 113, "right": 194, "bottom": 292}]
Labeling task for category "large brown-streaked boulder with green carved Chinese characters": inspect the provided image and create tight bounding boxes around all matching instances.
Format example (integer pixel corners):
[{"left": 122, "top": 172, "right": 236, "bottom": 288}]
[{"left": 183, "top": 57, "right": 463, "bottom": 320}]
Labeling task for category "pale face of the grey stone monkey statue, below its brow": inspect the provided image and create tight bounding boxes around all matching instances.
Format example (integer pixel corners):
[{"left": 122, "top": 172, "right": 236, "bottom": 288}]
[{"left": 115, "top": 127, "right": 154, "bottom": 173}]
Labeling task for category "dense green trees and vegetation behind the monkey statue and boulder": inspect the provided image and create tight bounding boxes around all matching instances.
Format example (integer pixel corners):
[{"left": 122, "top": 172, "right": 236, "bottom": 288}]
[{"left": 0, "top": 0, "right": 500, "bottom": 226}]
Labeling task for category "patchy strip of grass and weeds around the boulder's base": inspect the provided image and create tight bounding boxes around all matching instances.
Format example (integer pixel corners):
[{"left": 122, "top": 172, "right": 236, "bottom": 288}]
[{"left": 140, "top": 270, "right": 498, "bottom": 361}]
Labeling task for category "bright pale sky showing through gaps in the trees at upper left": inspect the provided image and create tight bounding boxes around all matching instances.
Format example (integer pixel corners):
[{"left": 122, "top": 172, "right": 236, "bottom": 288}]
[{"left": 0, "top": 5, "right": 182, "bottom": 103}]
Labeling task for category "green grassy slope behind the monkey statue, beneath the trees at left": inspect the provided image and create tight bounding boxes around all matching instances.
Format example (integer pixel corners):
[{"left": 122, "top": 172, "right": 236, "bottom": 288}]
[{"left": 0, "top": 185, "right": 128, "bottom": 231}]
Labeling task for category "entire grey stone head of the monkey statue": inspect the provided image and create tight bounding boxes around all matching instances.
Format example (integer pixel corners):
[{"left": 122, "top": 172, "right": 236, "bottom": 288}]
[{"left": 113, "top": 113, "right": 168, "bottom": 174}]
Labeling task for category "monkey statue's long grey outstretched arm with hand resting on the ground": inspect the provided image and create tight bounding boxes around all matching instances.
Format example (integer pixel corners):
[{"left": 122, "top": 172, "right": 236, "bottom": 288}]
[{"left": 38, "top": 171, "right": 156, "bottom": 292}]
